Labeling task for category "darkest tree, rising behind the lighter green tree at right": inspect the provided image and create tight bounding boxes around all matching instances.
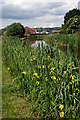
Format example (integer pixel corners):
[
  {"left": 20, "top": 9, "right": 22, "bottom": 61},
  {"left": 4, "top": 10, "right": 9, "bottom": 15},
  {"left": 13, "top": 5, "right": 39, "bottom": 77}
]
[{"left": 64, "top": 9, "right": 80, "bottom": 24}]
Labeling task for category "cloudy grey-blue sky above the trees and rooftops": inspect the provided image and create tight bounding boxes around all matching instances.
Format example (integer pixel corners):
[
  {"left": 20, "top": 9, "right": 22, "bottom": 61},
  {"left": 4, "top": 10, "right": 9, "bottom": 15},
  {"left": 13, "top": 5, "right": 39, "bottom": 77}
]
[{"left": 0, "top": 0, "right": 79, "bottom": 28}]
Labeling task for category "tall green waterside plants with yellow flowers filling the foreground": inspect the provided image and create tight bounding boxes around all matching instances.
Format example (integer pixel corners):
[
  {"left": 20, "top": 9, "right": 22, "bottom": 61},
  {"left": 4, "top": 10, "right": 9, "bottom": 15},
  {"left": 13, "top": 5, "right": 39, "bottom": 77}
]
[{"left": 3, "top": 38, "right": 80, "bottom": 119}]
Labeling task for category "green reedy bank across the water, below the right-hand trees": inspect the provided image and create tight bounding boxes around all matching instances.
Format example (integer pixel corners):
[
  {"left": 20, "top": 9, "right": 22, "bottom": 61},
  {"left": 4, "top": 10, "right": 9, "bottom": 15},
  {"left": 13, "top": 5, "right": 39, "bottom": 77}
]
[{"left": 43, "top": 34, "right": 80, "bottom": 47}]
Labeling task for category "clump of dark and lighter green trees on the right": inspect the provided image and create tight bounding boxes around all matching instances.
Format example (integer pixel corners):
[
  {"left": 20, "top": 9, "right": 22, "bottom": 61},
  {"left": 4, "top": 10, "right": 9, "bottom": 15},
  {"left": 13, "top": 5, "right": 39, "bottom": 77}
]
[{"left": 60, "top": 9, "right": 80, "bottom": 34}]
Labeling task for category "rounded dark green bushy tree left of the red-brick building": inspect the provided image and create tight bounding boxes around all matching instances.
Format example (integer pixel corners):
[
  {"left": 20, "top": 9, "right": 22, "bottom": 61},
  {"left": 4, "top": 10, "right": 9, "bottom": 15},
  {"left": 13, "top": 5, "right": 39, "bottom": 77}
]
[{"left": 6, "top": 23, "right": 25, "bottom": 37}]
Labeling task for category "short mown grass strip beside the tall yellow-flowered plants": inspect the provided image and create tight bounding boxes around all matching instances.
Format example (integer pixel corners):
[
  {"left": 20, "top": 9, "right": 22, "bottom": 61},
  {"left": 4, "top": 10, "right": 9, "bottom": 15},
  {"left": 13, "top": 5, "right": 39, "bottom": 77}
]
[{"left": 2, "top": 62, "right": 32, "bottom": 118}]
